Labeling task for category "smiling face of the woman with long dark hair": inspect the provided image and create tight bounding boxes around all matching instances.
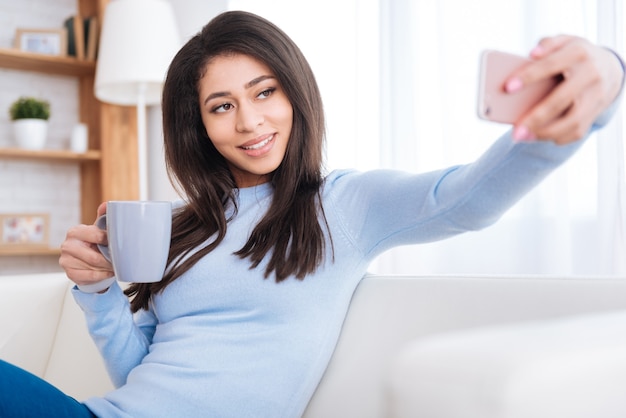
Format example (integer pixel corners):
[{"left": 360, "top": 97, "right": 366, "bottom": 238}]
[{"left": 199, "top": 54, "right": 293, "bottom": 188}]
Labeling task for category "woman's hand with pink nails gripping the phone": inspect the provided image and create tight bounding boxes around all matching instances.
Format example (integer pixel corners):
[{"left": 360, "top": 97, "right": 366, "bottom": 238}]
[{"left": 505, "top": 35, "right": 623, "bottom": 144}]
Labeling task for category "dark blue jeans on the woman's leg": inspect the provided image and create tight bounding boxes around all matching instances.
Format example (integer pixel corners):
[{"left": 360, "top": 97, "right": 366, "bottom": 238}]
[{"left": 0, "top": 360, "right": 95, "bottom": 418}]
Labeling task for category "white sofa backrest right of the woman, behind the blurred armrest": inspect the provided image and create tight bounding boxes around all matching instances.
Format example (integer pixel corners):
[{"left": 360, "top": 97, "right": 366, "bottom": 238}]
[{"left": 304, "top": 275, "right": 626, "bottom": 418}]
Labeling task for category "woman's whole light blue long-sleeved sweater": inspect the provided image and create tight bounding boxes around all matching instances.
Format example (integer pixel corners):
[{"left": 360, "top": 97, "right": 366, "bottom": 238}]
[{"left": 74, "top": 125, "right": 608, "bottom": 418}]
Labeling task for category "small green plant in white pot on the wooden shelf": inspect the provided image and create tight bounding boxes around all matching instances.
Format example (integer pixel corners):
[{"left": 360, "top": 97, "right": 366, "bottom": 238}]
[{"left": 9, "top": 97, "right": 50, "bottom": 149}]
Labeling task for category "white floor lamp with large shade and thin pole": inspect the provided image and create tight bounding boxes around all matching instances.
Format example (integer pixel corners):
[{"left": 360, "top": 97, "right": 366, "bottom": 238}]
[{"left": 94, "top": 0, "right": 180, "bottom": 200}]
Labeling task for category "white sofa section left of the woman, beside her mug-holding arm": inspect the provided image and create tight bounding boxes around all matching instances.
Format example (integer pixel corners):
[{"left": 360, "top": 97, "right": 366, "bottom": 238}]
[{"left": 0, "top": 273, "right": 113, "bottom": 400}]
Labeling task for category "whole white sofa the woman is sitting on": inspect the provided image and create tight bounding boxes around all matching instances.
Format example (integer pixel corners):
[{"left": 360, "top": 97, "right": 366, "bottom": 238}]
[{"left": 0, "top": 273, "right": 626, "bottom": 418}]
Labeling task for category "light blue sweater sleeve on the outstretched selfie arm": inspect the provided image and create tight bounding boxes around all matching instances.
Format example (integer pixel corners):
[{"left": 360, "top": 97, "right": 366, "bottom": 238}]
[{"left": 329, "top": 132, "right": 583, "bottom": 258}]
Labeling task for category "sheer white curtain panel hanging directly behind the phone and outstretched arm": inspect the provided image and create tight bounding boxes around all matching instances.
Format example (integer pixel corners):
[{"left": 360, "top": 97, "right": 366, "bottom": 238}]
[{"left": 375, "top": 0, "right": 625, "bottom": 275}]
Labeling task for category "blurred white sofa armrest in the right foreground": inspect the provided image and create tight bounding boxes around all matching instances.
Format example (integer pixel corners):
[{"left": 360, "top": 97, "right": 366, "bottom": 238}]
[{"left": 387, "top": 311, "right": 626, "bottom": 418}]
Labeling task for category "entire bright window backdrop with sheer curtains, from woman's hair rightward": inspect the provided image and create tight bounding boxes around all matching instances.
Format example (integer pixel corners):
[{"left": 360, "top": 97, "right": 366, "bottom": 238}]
[{"left": 229, "top": 0, "right": 626, "bottom": 275}]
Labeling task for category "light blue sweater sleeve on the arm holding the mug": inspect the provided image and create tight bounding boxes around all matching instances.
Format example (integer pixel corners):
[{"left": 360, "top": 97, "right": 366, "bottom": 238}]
[{"left": 72, "top": 282, "right": 157, "bottom": 387}]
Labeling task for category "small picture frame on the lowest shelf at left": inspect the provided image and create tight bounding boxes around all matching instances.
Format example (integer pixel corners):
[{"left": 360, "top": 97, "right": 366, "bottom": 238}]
[{"left": 0, "top": 213, "right": 50, "bottom": 248}]
